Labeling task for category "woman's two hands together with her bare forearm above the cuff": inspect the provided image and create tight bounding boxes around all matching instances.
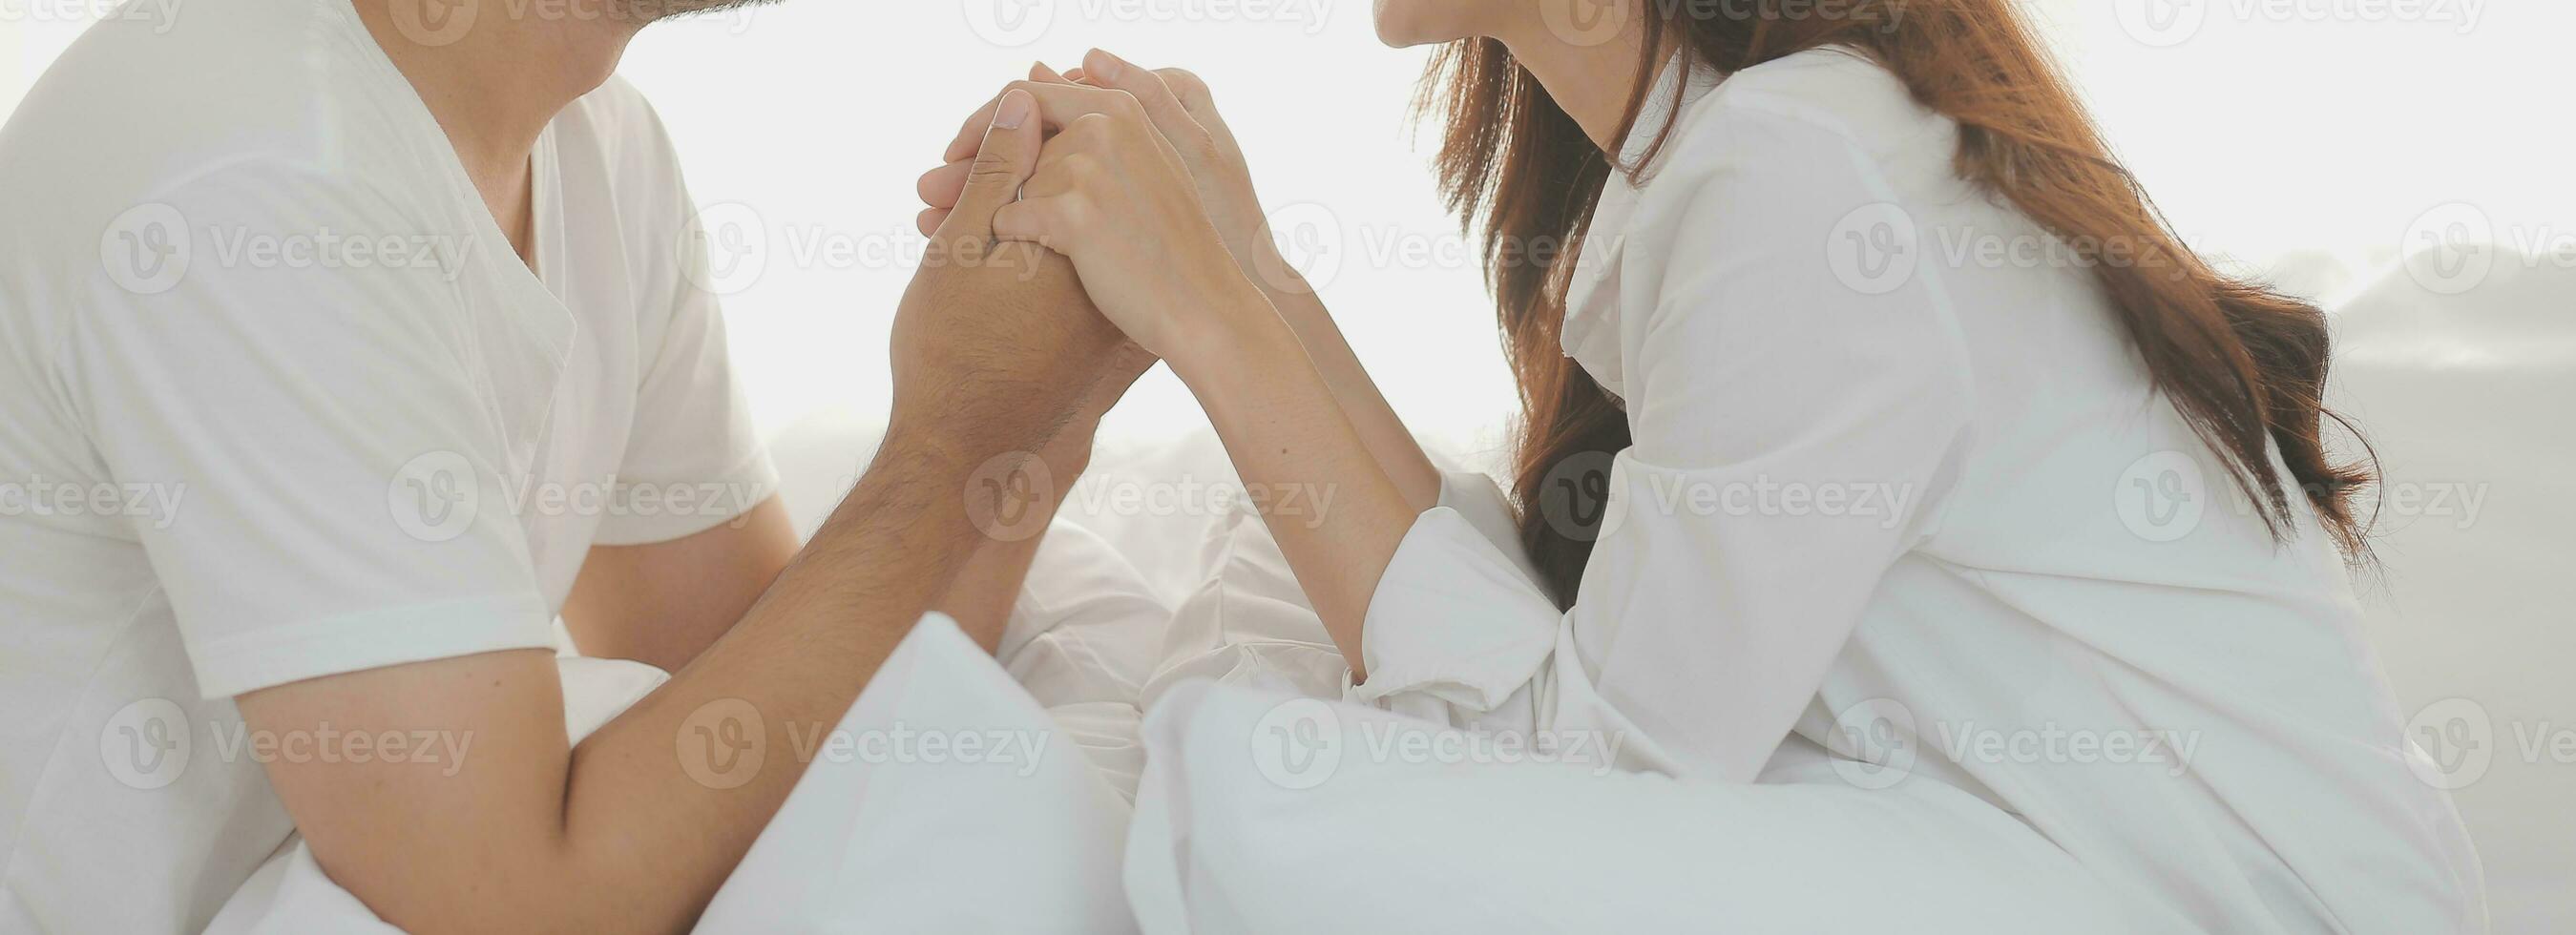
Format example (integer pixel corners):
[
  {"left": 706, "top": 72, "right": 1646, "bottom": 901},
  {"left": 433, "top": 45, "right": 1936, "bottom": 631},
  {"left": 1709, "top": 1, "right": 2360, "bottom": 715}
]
[{"left": 896, "top": 49, "right": 1440, "bottom": 675}]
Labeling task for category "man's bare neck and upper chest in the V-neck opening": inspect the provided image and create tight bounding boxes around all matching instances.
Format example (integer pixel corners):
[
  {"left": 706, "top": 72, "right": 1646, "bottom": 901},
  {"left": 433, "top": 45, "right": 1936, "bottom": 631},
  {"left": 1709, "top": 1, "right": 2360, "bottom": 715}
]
[{"left": 353, "top": 0, "right": 644, "bottom": 258}]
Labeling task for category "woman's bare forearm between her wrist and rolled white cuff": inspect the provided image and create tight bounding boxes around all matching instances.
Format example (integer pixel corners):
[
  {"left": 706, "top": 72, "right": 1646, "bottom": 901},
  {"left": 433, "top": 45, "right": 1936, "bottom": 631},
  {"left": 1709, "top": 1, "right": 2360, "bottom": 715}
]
[{"left": 1172, "top": 306, "right": 1440, "bottom": 677}]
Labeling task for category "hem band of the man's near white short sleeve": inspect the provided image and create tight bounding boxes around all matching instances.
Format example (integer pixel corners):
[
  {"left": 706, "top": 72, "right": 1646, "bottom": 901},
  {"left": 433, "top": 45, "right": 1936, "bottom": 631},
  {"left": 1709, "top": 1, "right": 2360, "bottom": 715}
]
[{"left": 188, "top": 595, "right": 554, "bottom": 700}]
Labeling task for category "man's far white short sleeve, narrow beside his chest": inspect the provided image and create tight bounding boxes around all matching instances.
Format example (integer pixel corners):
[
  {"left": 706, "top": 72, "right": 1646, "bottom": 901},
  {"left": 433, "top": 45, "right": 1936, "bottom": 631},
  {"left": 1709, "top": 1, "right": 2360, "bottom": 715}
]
[{"left": 593, "top": 130, "right": 778, "bottom": 546}]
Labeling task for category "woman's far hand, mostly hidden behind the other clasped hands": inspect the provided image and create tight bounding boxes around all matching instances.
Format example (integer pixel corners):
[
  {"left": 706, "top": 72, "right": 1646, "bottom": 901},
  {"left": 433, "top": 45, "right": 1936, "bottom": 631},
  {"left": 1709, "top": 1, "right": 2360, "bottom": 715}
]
[{"left": 920, "top": 49, "right": 1311, "bottom": 296}]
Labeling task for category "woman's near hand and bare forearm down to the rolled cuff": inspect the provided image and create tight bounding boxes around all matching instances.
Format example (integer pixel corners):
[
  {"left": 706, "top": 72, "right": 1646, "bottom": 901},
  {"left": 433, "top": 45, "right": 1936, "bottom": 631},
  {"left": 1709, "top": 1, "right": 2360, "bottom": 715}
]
[{"left": 969, "top": 74, "right": 1437, "bottom": 670}]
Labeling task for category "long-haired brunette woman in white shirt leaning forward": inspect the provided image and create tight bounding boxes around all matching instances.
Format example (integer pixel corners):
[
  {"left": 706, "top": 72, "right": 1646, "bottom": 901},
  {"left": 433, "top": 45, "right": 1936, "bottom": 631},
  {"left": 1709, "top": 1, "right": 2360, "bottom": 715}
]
[{"left": 925, "top": 0, "right": 2483, "bottom": 932}]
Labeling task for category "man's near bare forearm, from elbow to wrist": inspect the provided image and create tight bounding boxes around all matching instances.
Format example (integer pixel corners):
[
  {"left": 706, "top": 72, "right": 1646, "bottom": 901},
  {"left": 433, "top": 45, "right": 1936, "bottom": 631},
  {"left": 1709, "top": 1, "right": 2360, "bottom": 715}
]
[{"left": 561, "top": 435, "right": 984, "bottom": 930}]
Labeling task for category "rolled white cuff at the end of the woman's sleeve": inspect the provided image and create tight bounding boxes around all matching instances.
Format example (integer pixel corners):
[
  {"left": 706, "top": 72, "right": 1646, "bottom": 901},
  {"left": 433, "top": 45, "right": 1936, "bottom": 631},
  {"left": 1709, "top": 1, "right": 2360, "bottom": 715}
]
[{"left": 1350, "top": 509, "right": 1563, "bottom": 714}]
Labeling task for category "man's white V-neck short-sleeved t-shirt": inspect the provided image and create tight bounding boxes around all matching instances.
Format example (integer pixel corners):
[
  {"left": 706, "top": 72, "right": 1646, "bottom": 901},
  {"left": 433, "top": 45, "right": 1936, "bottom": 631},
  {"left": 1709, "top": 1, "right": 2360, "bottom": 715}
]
[{"left": 0, "top": 0, "right": 775, "bottom": 932}]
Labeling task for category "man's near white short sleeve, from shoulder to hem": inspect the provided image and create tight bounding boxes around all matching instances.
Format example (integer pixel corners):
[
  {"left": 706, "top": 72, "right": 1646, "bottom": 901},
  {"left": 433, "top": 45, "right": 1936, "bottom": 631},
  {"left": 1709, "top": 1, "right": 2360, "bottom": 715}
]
[{"left": 59, "top": 165, "right": 552, "bottom": 698}]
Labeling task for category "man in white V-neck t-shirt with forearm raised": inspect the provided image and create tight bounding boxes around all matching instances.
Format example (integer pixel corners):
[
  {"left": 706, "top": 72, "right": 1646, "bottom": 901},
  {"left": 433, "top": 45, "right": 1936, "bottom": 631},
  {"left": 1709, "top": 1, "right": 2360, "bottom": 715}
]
[{"left": 0, "top": 0, "right": 1149, "bottom": 932}]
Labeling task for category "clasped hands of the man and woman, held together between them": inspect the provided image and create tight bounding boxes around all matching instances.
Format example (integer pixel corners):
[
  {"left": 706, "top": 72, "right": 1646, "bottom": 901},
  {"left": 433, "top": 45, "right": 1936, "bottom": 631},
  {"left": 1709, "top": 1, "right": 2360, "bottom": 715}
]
[{"left": 894, "top": 52, "right": 1306, "bottom": 491}]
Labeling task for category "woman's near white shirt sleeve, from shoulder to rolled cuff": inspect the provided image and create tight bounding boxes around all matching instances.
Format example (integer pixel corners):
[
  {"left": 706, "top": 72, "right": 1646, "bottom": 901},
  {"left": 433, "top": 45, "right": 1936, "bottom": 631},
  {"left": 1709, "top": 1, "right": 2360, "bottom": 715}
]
[{"left": 1350, "top": 111, "right": 1973, "bottom": 780}]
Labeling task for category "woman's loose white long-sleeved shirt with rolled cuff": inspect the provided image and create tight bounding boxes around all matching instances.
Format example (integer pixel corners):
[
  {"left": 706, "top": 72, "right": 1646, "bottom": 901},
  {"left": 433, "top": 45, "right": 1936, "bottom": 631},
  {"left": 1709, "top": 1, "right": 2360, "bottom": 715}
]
[{"left": 1350, "top": 49, "right": 2483, "bottom": 932}]
